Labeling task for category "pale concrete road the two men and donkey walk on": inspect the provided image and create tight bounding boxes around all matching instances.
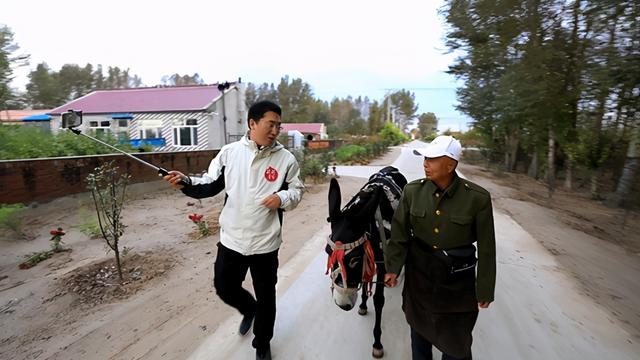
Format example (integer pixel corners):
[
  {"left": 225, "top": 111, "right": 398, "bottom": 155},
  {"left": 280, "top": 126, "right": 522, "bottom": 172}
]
[{"left": 190, "top": 142, "right": 640, "bottom": 360}]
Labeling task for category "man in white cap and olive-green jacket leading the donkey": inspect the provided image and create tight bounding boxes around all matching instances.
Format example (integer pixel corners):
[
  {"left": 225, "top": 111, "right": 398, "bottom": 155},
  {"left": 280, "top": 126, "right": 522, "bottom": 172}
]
[{"left": 385, "top": 136, "right": 496, "bottom": 360}]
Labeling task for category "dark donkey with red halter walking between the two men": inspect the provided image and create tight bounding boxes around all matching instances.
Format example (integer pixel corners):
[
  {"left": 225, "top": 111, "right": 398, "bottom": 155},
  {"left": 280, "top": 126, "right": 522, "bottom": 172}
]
[{"left": 325, "top": 166, "right": 407, "bottom": 358}]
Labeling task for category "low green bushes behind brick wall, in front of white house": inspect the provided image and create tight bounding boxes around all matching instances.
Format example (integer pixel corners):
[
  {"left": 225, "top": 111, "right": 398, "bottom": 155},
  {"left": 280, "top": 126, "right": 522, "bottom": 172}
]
[{"left": 0, "top": 125, "right": 140, "bottom": 160}]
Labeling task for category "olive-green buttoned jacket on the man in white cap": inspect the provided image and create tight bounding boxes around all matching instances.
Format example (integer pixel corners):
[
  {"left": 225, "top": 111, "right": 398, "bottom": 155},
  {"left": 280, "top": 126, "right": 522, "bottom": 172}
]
[{"left": 385, "top": 174, "right": 496, "bottom": 302}]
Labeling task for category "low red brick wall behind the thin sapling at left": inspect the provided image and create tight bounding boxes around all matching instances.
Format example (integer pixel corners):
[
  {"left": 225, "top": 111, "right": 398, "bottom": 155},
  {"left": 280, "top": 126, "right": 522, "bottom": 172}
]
[{"left": 0, "top": 150, "right": 218, "bottom": 204}]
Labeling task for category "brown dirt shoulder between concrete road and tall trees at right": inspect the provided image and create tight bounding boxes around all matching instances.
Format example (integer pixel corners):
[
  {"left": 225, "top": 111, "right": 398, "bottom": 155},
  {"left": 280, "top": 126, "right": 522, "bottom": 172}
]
[{"left": 459, "top": 164, "right": 640, "bottom": 341}]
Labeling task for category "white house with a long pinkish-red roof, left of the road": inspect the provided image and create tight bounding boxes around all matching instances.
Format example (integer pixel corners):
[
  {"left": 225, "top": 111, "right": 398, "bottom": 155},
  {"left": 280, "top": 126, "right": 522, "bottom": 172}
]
[{"left": 49, "top": 82, "right": 247, "bottom": 151}]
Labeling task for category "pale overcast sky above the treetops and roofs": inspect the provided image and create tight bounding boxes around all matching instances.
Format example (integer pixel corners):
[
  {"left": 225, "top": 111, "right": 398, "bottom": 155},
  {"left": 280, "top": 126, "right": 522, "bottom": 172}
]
[{"left": 0, "top": 0, "right": 468, "bottom": 130}]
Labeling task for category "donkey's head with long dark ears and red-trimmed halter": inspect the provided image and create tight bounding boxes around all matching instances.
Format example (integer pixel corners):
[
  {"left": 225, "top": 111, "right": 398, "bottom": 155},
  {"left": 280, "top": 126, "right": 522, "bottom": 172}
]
[{"left": 326, "top": 179, "right": 379, "bottom": 310}]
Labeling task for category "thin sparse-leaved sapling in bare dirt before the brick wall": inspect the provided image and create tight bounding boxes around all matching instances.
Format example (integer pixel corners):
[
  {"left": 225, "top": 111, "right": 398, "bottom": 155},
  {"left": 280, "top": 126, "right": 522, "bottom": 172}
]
[{"left": 87, "top": 162, "right": 130, "bottom": 281}]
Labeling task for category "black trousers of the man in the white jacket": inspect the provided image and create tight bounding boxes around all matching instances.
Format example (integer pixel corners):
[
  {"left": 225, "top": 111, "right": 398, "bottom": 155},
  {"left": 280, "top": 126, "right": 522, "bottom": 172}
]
[{"left": 213, "top": 243, "right": 278, "bottom": 350}]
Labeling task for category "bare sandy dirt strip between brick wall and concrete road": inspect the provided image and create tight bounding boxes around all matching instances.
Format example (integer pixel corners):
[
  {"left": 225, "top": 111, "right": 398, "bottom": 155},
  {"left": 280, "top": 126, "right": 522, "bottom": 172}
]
[{"left": 0, "top": 178, "right": 363, "bottom": 360}]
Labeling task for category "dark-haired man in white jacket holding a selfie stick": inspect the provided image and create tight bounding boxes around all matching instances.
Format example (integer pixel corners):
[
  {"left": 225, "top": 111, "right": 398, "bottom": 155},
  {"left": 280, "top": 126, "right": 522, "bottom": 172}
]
[{"left": 164, "top": 101, "right": 304, "bottom": 359}]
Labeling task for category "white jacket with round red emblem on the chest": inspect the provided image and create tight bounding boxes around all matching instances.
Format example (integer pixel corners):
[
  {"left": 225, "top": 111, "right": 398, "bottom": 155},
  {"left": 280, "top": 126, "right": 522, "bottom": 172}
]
[{"left": 183, "top": 135, "right": 304, "bottom": 255}]
